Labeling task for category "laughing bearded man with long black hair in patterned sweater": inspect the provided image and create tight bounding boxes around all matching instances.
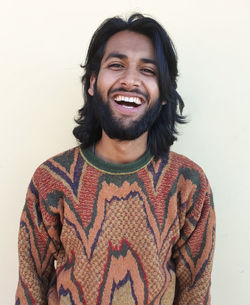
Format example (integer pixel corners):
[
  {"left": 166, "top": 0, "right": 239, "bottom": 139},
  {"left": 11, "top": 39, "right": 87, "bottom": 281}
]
[{"left": 16, "top": 14, "right": 215, "bottom": 305}]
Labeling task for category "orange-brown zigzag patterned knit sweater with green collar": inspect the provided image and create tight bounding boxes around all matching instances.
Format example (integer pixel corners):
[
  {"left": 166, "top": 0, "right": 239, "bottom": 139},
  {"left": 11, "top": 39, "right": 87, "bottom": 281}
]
[{"left": 16, "top": 147, "right": 215, "bottom": 305}]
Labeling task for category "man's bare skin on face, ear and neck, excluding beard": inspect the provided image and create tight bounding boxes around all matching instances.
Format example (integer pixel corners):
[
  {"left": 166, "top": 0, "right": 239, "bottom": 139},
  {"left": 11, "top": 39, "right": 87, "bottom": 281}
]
[{"left": 88, "top": 31, "right": 164, "bottom": 163}]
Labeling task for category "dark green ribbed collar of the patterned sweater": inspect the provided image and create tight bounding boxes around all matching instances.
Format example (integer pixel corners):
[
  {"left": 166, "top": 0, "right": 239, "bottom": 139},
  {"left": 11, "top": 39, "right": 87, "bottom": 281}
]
[{"left": 80, "top": 146, "right": 153, "bottom": 175}]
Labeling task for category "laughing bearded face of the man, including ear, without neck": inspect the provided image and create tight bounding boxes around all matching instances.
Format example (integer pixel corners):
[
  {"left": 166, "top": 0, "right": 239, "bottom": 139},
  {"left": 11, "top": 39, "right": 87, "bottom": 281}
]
[{"left": 88, "top": 31, "right": 161, "bottom": 139}]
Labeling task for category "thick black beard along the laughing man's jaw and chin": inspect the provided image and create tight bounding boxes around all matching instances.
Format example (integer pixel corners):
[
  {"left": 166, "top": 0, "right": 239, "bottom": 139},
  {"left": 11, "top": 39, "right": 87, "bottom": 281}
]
[{"left": 92, "top": 90, "right": 162, "bottom": 141}]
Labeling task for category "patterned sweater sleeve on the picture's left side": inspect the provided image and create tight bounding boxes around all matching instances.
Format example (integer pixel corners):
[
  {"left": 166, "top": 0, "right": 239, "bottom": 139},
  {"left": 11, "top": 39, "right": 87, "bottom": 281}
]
[{"left": 16, "top": 171, "right": 59, "bottom": 305}]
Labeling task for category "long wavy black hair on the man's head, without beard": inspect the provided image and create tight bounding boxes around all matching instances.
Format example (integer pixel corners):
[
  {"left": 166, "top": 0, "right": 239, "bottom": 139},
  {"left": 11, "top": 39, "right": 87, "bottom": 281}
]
[{"left": 73, "top": 13, "right": 185, "bottom": 159}]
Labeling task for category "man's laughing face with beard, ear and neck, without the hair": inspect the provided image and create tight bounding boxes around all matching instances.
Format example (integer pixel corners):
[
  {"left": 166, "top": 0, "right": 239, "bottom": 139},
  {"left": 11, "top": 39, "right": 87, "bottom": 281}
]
[{"left": 88, "top": 30, "right": 162, "bottom": 163}]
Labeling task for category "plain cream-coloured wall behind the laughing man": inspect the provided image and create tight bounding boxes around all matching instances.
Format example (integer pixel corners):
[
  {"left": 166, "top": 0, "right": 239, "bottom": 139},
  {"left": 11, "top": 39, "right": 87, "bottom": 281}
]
[{"left": 0, "top": 0, "right": 250, "bottom": 305}]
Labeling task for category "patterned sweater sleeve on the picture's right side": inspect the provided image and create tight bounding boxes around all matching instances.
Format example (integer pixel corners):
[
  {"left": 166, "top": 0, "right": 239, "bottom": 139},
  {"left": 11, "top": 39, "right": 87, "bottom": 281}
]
[{"left": 173, "top": 177, "right": 215, "bottom": 305}]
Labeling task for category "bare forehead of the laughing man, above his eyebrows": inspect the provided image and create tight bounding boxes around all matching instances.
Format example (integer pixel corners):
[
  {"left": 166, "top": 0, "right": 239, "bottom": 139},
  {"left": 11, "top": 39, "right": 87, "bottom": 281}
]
[{"left": 104, "top": 31, "right": 155, "bottom": 60}]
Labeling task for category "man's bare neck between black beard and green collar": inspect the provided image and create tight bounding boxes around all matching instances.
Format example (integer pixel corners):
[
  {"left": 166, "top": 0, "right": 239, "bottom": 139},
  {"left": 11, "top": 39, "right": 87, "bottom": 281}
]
[{"left": 95, "top": 131, "right": 148, "bottom": 163}]
